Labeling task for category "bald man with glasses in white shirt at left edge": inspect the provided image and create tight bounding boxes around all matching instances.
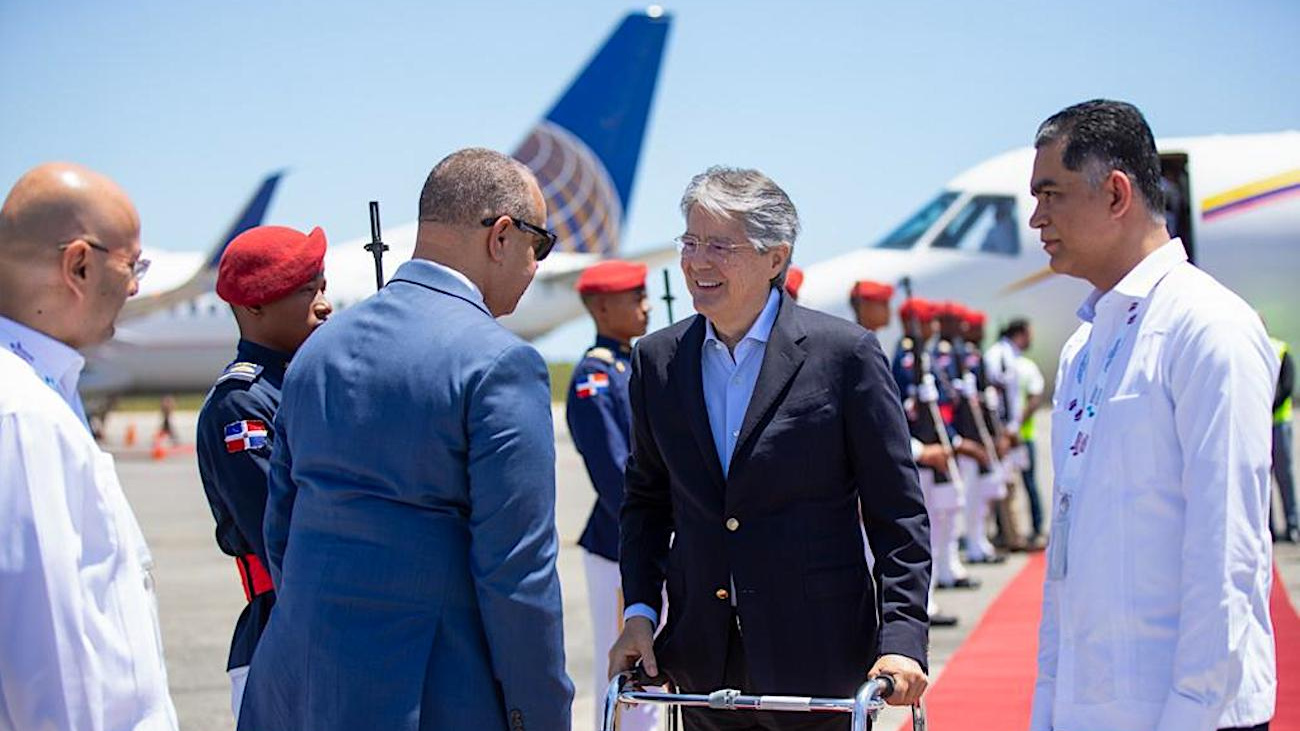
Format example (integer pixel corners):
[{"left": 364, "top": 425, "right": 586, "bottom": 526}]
[{"left": 0, "top": 163, "right": 177, "bottom": 731}]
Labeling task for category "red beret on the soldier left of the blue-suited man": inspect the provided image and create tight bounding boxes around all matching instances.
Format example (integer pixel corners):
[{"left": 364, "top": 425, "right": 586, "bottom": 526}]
[{"left": 217, "top": 226, "right": 325, "bottom": 307}]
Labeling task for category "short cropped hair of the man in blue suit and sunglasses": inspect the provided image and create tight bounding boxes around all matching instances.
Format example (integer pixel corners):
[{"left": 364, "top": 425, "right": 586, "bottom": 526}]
[{"left": 420, "top": 147, "right": 535, "bottom": 226}]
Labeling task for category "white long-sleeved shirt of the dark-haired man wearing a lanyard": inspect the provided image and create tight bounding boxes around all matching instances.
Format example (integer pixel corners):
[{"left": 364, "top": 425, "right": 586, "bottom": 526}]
[{"left": 1031, "top": 239, "right": 1278, "bottom": 731}]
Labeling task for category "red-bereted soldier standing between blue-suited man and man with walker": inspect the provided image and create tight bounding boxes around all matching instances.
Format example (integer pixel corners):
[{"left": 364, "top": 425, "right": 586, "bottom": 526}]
[{"left": 566, "top": 261, "right": 659, "bottom": 731}]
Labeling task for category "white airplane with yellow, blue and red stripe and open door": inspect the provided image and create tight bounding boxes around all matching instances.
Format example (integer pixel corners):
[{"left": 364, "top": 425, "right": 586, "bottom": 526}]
[{"left": 800, "top": 131, "right": 1300, "bottom": 380}]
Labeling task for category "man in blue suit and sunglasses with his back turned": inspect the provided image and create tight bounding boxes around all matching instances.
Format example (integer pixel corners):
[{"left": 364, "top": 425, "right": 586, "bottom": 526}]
[{"left": 239, "top": 150, "right": 573, "bottom": 731}]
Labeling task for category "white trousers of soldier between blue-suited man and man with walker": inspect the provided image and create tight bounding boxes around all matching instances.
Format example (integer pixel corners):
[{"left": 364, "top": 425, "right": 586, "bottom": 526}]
[{"left": 582, "top": 550, "right": 659, "bottom": 731}]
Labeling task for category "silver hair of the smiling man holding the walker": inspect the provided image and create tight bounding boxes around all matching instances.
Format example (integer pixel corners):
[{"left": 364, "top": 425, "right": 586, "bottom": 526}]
[{"left": 681, "top": 165, "right": 800, "bottom": 286}]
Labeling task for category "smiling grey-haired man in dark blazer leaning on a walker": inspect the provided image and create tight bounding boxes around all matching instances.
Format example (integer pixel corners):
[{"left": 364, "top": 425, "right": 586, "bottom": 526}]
[{"left": 610, "top": 168, "right": 930, "bottom": 730}]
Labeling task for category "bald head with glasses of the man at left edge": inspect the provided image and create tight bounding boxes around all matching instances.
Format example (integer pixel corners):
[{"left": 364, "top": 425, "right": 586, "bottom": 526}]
[{"left": 0, "top": 163, "right": 140, "bottom": 347}]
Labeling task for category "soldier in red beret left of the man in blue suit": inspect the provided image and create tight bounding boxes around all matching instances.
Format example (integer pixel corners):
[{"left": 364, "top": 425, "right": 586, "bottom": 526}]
[{"left": 196, "top": 226, "right": 332, "bottom": 721}]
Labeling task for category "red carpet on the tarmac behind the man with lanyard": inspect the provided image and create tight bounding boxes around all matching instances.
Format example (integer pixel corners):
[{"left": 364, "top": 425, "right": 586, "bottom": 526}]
[{"left": 925, "top": 553, "right": 1300, "bottom": 731}]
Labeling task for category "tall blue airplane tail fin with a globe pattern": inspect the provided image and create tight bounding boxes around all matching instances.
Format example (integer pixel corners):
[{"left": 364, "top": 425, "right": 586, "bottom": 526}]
[{"left": 514, "top": 10, "right": 672, "bottom": 256}]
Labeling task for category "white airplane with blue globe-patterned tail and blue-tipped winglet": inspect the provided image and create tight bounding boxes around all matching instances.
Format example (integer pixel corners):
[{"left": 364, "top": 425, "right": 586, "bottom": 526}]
[{"left": 82, "top": 8, "right": 675, "bottom": 400}]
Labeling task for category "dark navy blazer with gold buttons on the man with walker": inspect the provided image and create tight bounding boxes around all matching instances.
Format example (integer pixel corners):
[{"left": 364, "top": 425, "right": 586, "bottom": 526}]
[{"left": 620, "top": 290, "right": 930, "bottom": 696}]
